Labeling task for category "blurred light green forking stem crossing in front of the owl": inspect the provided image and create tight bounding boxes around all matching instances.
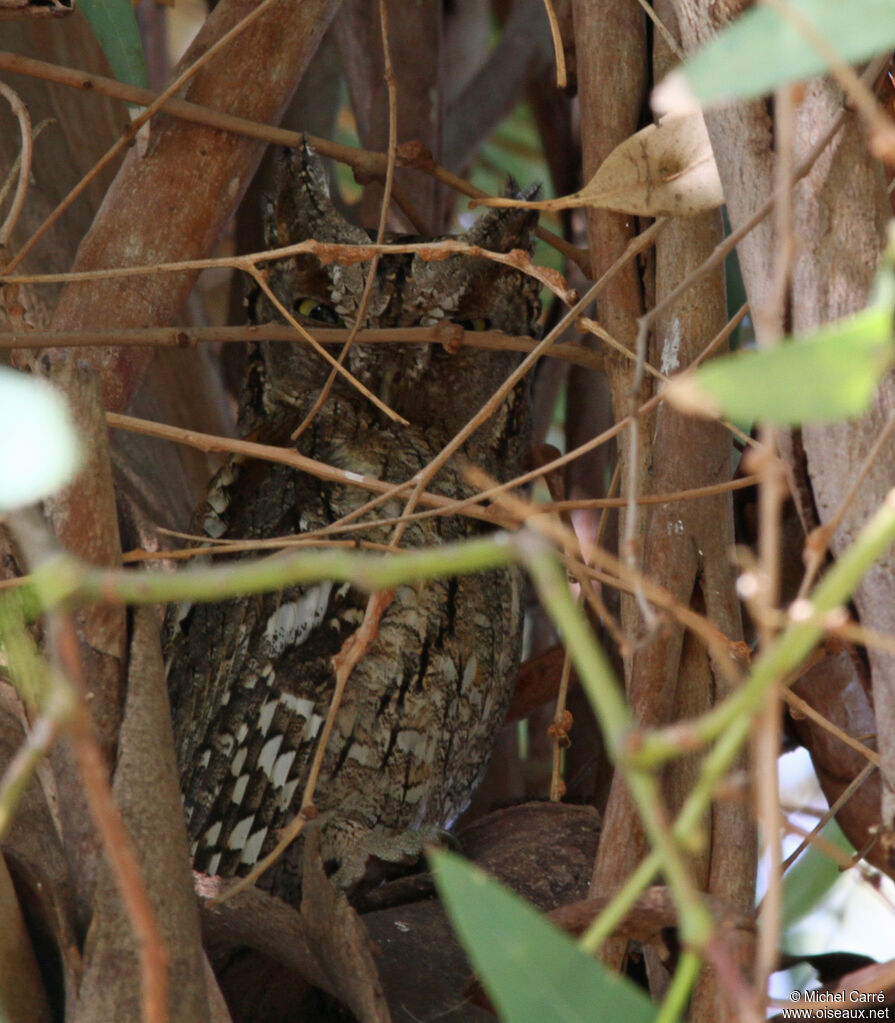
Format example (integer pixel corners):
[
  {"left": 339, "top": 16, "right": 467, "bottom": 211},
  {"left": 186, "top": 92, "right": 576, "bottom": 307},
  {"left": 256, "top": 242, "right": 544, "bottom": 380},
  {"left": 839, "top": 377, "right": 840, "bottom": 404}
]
[{"left": 0, "top": 490, "right": 895, "bottom": 1021}]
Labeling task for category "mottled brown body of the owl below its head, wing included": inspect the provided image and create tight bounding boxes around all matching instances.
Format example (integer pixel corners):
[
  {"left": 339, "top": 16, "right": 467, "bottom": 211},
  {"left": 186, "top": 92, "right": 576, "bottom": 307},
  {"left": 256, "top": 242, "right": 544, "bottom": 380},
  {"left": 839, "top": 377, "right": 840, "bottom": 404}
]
[{"left": 166, "top": 415, "right": 521, "bottom": 898}]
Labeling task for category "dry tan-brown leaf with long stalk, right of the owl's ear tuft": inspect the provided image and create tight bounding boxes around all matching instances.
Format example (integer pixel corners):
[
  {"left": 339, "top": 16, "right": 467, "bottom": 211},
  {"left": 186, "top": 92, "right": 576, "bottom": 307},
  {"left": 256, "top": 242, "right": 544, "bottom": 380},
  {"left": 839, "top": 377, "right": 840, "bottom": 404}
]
[{"left": 469, "top": 112, "right": 724, "bottom": 217}]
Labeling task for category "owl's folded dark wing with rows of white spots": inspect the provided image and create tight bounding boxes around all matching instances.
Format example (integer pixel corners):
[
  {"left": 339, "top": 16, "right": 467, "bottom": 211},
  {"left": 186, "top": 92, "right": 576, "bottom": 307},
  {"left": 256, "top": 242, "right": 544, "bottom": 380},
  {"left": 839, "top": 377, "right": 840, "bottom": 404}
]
[{"left": 168, "top": 568, "right": 362, "bottom": 876}]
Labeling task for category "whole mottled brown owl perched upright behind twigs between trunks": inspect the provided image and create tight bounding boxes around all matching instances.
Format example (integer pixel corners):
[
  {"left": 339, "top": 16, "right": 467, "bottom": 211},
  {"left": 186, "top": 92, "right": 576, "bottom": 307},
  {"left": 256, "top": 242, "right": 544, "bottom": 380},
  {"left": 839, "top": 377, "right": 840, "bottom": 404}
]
[{"left": 165, "top": 148, "right": 538, "bottom": 903}]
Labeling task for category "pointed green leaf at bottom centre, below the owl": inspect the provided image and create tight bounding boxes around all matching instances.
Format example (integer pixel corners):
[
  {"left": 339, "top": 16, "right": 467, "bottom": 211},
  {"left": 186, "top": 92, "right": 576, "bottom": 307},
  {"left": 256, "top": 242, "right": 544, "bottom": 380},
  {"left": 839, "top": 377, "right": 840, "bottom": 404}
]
[{"left": 430, "top": 851, "right": 657, "bottom": 1023}]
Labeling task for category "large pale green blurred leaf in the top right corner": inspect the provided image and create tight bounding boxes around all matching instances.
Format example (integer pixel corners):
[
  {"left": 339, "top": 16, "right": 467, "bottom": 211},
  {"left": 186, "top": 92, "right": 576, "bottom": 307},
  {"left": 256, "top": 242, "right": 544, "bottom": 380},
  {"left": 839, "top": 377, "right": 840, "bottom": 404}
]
[{"left": 669, "top": 0, "right": 895, "bottom": 104}]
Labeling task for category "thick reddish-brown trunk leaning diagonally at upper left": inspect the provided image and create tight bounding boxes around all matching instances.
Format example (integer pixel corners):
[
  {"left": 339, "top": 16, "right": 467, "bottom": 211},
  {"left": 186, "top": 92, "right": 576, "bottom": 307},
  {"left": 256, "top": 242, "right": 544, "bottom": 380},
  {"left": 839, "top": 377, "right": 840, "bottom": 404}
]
[{"left": 44, "top": 0, "right": 339, "bottom": 411}]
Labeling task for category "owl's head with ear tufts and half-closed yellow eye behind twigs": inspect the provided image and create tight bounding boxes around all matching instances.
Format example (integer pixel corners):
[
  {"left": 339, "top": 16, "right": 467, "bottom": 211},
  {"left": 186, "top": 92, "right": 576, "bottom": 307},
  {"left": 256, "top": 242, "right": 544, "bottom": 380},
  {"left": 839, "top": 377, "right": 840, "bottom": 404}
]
[{"left": 248, "top": 145, "right": 539, "bottom": 421}]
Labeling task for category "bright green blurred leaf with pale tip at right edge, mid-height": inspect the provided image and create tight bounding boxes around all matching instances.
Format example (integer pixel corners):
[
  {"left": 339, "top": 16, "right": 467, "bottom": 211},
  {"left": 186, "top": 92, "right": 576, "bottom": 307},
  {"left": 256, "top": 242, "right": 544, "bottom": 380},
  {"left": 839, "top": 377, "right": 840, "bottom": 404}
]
[{"left": 665, "top": 292, "right": 893, "bottom": 426}]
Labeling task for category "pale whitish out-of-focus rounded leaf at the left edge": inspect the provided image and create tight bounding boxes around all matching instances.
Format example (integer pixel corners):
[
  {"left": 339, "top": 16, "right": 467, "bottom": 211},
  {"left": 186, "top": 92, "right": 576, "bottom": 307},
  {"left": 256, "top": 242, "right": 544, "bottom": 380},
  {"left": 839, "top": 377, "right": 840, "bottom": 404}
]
[{"left": 0, "top": 367, "right": 80, "bottom": 513}]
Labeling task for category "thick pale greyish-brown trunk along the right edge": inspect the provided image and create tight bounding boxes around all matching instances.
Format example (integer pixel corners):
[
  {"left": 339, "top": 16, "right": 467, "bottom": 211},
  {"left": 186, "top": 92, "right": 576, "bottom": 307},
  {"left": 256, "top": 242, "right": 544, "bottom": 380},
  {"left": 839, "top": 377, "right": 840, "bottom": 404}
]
[{"left": 676, "top": 0, "right": 895, "bottom": 847}]
